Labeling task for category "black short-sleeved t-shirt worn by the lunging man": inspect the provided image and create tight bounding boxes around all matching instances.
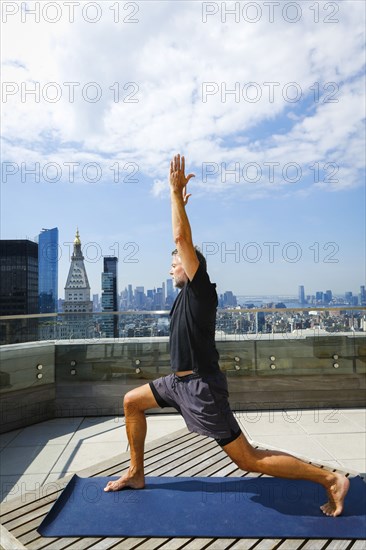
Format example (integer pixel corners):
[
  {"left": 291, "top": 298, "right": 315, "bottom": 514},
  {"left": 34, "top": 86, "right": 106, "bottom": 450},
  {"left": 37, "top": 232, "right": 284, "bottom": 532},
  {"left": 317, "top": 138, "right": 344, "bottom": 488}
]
[{"left": 170, "top": 264, "right": 220, "bottom": 376}]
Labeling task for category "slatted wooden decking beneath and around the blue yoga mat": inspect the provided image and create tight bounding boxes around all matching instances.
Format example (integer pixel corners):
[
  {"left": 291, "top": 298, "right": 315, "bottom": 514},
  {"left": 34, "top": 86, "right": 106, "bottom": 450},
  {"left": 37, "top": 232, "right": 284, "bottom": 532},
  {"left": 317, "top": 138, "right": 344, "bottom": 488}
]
[{"left": 1, "top": 428, "right": 366, "bottom": 550}]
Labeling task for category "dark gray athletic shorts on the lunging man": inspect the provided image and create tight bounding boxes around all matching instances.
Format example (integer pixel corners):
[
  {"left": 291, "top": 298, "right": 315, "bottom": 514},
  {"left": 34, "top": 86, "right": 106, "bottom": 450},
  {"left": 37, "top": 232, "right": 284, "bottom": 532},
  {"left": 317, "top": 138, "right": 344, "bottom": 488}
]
[{"left": 150, "top": 371, "right": 241, "bottom": 446}]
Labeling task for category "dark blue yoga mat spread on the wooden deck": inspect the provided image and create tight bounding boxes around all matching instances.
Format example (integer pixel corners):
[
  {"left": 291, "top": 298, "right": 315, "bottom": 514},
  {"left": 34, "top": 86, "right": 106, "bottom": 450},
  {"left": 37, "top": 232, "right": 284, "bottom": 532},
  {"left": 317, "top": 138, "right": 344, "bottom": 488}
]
[{"left": 38, "top": 475, "right": 366, "bottom": 539}]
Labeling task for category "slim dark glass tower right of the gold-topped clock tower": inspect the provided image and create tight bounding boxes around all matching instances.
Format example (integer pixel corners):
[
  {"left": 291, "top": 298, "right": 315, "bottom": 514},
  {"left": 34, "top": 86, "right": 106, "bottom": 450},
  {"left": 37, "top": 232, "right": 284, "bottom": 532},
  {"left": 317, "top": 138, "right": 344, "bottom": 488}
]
[{"left": 102, "top": 256, "right": 119, "bottom": 338}]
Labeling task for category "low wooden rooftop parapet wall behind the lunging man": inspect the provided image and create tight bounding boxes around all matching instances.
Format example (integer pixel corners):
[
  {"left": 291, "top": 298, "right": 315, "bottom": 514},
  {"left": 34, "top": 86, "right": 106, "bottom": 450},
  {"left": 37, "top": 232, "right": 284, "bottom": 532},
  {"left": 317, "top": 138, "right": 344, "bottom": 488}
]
[{"left": 0, "top": 334, "right": 366, "bottom": 432}]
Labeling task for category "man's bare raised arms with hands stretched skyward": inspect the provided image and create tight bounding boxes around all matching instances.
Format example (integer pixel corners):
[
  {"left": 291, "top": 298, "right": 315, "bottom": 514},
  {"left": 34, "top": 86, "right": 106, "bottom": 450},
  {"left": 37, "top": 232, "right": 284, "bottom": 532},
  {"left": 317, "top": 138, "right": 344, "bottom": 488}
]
[{"left": 169, "top": 155, "right": 199, "bottom": 281}]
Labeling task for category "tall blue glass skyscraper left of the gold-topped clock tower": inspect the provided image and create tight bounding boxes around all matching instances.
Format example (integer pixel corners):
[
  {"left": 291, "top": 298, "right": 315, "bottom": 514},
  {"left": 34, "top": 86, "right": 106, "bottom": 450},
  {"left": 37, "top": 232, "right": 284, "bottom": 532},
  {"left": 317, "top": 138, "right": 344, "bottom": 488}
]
[{"left": 38, "top": 227, "right": 58, "bottom": 313}]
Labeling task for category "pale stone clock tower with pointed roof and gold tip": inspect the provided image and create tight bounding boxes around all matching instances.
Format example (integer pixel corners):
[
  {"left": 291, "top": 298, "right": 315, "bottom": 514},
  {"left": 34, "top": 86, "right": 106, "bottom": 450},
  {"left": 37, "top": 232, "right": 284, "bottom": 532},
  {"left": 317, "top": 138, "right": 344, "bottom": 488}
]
[{"left": 64, "top": 230, "right": 95, "bottom": 338}]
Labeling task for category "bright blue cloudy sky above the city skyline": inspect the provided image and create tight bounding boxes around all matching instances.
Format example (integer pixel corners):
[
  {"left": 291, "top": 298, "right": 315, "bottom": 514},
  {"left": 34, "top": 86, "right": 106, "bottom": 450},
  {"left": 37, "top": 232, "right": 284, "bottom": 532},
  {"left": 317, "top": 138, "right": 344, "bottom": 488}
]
[{"left": 1, "top": 1, "right": 365, "bottom": 296}]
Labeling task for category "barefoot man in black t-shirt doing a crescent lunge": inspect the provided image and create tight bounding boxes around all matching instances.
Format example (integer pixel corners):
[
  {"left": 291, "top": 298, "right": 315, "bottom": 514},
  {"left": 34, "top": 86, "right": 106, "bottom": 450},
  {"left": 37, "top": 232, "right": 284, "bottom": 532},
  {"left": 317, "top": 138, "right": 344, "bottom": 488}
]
[{"left": 104, "top": 155, "right": 349, "bottom": 516}]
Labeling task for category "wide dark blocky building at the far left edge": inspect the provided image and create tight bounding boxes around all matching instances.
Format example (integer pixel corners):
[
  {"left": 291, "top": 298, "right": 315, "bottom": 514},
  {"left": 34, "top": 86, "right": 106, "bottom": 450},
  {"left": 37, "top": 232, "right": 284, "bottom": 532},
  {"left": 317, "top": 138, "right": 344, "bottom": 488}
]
[{"left": 0, "top": 240, "right": 39, "bottom": 344}]
